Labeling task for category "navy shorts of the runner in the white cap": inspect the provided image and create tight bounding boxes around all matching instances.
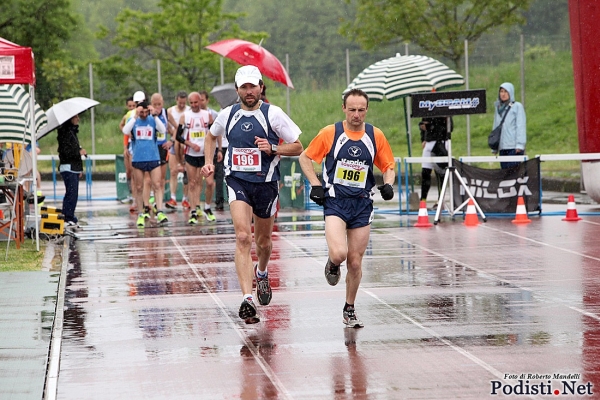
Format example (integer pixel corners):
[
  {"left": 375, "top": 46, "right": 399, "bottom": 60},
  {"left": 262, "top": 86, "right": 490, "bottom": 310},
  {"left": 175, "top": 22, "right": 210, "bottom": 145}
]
[{"left": 225, "top": 176, "right": 279, "bottom": 218}]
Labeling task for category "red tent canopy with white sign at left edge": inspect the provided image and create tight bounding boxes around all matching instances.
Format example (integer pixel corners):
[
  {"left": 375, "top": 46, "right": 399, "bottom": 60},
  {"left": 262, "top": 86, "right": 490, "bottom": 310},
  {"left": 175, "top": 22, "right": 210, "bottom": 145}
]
[{"left": 0, "top": 37, "right": 35, "bottom": 86}]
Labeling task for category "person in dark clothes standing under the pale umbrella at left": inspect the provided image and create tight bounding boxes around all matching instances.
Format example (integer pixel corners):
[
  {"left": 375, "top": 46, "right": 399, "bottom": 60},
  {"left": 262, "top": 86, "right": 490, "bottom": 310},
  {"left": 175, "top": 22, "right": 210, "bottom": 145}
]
[{"left": 58, "top": 115, "right": 87, "bottom": 226}]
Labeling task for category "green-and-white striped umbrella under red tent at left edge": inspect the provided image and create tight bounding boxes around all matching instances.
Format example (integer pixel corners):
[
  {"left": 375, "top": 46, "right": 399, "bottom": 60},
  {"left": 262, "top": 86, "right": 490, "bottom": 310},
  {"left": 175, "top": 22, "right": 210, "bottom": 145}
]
[{"left": 0, "top": 85, "right": 48, "bottom": 144}]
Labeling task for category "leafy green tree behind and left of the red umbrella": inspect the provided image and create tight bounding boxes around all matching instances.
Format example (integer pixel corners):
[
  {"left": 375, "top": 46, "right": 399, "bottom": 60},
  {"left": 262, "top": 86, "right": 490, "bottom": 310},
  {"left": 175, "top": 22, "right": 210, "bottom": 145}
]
[{"left": 102, "top": 0, "right": 266, "bottom": 101}]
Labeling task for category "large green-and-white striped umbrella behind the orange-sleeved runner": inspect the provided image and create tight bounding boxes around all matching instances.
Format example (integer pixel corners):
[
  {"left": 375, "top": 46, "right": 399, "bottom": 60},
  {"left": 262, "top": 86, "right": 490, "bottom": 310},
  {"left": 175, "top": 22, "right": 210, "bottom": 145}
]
[{"left": 344, "top": 54, "right": 465, "bottom": 101}]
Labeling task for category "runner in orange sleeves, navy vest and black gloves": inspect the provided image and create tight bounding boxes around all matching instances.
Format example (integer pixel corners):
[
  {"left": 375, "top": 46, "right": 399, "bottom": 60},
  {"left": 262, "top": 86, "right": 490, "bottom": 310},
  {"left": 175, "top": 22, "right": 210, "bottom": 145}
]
[{"left": 298, "top": 89, "right": 396, "bottom": 328}]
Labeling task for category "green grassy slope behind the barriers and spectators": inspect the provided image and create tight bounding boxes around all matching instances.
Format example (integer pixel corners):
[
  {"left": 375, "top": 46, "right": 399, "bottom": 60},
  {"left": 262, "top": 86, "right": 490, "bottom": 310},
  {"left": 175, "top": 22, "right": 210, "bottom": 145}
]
[{"left": 40, "top": 53, "right": 579, "bottom": 176}]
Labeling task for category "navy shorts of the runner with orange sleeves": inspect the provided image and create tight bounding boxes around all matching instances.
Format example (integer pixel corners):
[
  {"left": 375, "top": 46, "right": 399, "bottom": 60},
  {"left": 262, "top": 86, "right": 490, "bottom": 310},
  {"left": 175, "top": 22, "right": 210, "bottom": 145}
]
[{"left": 323, "top": 197, "right": 373, "bottom": 229}]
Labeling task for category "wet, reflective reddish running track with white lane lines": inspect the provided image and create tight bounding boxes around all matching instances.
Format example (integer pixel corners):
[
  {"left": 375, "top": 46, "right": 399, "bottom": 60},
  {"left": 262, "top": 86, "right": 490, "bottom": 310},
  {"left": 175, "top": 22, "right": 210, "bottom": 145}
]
[{"left": 44, "top": 198, "right": 600, "bottom": 400}]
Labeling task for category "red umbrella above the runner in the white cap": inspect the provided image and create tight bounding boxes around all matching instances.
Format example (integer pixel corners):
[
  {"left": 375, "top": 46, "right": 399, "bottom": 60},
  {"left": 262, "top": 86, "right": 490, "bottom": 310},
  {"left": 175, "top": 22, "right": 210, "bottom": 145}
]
[{"left": 206, "top": 39, "right": 294, "bottom": 89}]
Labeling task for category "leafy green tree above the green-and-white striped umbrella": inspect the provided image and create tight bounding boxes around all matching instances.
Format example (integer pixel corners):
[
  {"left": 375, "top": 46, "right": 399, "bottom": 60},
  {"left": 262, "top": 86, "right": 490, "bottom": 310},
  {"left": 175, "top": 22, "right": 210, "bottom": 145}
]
[{"left": 342, "top": 0, "right": 532, "bottom": 69}]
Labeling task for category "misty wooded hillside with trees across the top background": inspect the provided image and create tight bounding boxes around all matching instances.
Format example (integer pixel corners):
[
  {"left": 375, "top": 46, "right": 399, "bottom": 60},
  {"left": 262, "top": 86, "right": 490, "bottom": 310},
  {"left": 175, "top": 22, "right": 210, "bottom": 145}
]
[{"left": 0, "top": 0, "right": 568, "bottom": 112}]
